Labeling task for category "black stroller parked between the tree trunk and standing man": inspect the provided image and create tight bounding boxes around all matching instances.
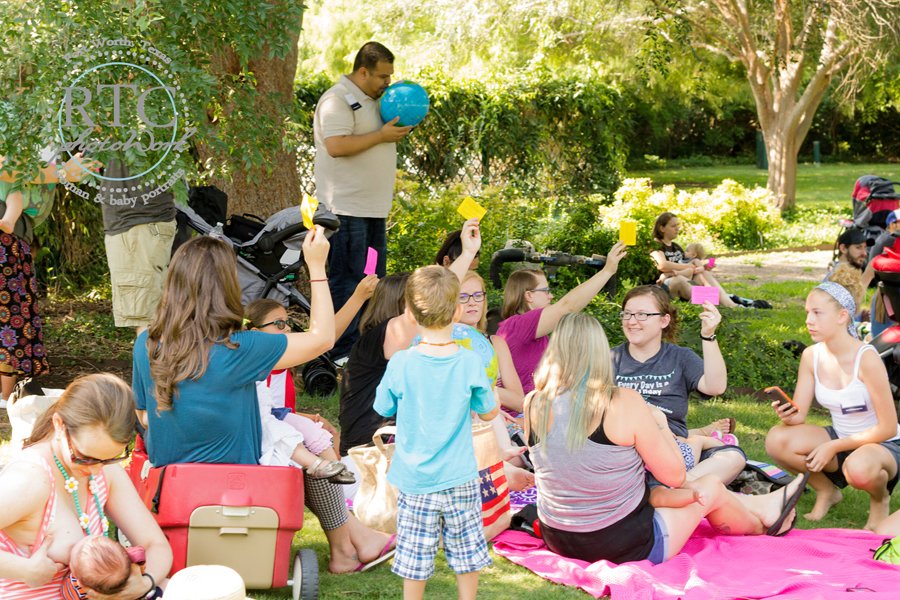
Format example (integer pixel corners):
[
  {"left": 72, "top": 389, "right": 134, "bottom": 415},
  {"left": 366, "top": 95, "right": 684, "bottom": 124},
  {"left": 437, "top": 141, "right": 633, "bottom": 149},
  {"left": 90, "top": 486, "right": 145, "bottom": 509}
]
[{"left": 172, "top": 186, "right": 340, "bottom": 396}]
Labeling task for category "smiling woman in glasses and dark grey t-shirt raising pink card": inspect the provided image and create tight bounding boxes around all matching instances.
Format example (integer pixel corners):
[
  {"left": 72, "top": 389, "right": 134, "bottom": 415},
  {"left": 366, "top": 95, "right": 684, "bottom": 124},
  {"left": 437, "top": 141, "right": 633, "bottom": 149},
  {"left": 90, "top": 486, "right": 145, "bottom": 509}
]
[{"left": 612, "top": 285, "right": 746, "bottom": 483}]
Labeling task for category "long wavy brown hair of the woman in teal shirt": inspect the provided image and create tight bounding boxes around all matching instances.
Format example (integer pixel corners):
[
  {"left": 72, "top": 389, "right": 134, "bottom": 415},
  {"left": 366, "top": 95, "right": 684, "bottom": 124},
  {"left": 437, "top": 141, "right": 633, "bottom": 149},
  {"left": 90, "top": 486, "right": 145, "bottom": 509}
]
[{"left": 147, "top": 236, "right": 244, "bottom": 410}]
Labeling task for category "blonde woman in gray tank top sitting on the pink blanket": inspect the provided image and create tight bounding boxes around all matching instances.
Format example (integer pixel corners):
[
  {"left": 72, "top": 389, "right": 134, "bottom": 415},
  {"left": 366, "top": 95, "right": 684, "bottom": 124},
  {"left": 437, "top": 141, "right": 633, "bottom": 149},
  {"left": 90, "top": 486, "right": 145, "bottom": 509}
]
[{"left": 525, "top": 313, "right": 805, "bottom": 563}]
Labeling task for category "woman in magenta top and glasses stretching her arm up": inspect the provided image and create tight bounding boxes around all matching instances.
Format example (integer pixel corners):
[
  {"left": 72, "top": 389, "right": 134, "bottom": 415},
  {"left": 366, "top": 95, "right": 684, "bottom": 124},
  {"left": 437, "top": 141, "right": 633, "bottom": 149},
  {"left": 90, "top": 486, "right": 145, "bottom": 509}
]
[{"left": 497, "top": 242, "right": 626, "bottom": 394}]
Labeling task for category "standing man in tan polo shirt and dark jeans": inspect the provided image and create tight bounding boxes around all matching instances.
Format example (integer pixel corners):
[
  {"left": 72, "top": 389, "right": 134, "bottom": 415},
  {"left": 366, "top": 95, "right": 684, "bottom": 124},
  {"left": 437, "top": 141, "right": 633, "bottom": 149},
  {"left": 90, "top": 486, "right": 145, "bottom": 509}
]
[{"left": 313, "top": 42, "right": 412, "bottom": 357}]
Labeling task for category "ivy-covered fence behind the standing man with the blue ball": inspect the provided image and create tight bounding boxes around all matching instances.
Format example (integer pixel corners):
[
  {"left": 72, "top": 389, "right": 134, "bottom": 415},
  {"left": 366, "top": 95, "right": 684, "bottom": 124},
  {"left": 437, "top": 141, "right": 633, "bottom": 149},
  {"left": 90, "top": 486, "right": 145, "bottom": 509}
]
[{"left": 296, "top": 69, "right": 629, "bottom": 198}]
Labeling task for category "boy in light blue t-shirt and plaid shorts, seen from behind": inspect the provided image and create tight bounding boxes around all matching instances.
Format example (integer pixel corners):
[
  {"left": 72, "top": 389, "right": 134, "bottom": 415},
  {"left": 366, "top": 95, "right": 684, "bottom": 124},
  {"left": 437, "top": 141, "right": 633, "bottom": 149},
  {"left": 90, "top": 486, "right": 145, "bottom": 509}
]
[{"left": 375, "top": 266, "right": 497, "bottom": 599}]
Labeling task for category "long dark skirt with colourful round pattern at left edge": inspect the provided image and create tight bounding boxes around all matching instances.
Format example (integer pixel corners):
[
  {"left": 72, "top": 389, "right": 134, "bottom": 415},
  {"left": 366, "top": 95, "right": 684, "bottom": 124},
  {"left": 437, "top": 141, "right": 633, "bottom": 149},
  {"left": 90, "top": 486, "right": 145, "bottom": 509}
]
[{"left": 0, "top": 233, "right": 50, "bottom": 376}]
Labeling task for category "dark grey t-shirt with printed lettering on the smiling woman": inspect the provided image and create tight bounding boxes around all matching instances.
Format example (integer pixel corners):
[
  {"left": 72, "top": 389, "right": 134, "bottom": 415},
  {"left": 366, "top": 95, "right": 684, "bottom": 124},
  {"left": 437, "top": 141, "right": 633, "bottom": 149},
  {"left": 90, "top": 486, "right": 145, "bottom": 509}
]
[{"left": 612, "top": 342, "right": 703, "bottom": 437}]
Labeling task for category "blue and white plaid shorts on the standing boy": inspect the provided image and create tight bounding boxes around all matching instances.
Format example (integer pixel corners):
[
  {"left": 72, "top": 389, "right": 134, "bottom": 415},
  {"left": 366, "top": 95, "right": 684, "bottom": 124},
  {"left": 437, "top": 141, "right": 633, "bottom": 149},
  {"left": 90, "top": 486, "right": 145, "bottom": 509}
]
[{"left": 391, "top": 479, "right": 491, "bottom": 580}]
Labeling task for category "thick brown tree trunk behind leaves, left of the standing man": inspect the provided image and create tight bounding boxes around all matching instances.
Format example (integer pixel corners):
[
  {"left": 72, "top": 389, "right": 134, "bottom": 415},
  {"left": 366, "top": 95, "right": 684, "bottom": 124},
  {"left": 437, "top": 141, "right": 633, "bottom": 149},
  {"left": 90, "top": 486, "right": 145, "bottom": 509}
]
[{"left": 198, "top": 30, "right": 301, "bottom": 219}]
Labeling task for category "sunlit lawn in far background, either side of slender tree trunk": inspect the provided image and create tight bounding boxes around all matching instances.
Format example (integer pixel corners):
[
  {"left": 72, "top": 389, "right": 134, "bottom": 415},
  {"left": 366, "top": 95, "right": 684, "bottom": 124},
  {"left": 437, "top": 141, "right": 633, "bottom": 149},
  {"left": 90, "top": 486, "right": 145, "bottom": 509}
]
[{"left": 627, "top": 163, "right": 900, "bottom": 213}]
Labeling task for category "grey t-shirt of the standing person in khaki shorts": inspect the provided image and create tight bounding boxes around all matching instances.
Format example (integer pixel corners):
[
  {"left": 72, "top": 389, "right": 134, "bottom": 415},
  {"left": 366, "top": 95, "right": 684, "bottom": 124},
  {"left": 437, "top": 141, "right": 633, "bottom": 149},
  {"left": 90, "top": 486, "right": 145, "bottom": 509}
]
[{"left": 97, "top": 160, "right": 175, "bottom": 235}]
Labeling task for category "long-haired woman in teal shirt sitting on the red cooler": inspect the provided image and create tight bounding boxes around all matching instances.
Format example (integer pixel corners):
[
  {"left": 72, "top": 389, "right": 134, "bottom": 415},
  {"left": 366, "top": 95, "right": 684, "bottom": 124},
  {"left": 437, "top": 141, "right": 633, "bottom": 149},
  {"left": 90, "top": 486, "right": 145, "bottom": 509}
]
[{"left": 133, "top": 232, "right": 393, "bottom": 573}]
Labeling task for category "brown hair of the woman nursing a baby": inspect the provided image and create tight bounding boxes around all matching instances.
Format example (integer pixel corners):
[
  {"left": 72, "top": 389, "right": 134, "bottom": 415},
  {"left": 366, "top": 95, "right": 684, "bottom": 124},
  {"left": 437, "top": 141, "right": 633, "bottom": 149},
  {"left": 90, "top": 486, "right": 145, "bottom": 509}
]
[{"left": 22, "top": 373, "right": 137, "bottom": 448}]
